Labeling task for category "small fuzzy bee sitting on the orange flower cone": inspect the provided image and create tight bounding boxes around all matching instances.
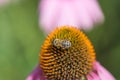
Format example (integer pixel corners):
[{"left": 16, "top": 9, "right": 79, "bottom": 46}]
[{"left": 53, "top": 39, "right": 71, "bottom": 49}]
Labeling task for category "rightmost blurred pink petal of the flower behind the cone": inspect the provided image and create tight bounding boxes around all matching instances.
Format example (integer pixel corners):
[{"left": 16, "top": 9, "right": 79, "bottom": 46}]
[{"left": 73, "top": 0, "right": 104, "bottom": 30}]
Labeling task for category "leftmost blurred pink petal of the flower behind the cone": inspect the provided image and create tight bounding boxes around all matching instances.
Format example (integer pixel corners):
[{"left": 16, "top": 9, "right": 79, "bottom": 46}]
[{"left": 39, "top": 0, "right": 59, "bottom": 32}]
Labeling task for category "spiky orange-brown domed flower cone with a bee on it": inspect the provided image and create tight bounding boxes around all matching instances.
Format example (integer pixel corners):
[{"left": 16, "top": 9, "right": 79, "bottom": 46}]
[{"left": 40, "top": 26, "right": 95, "bottom": 80}]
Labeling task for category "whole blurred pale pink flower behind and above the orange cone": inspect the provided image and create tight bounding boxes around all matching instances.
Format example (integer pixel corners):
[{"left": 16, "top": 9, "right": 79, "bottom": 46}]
[{"left": 39, "top": 0, "right": 104, "bottom": 33}]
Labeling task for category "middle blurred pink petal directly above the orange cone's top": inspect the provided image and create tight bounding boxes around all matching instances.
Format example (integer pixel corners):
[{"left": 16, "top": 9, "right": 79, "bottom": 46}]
[{"left": 56, "top": 1, "right": 79, "bottom": 26}]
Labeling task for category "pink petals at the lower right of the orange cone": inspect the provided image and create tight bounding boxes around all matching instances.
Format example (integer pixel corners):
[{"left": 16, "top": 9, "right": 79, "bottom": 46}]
[{"left": 87, "top": 62, "right": 115, "bottom": 80}]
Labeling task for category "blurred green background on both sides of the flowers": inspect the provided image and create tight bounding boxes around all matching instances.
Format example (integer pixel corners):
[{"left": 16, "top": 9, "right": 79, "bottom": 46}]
[{"left": 0, "top": 0, "right": 120, "bottom": 80}]
